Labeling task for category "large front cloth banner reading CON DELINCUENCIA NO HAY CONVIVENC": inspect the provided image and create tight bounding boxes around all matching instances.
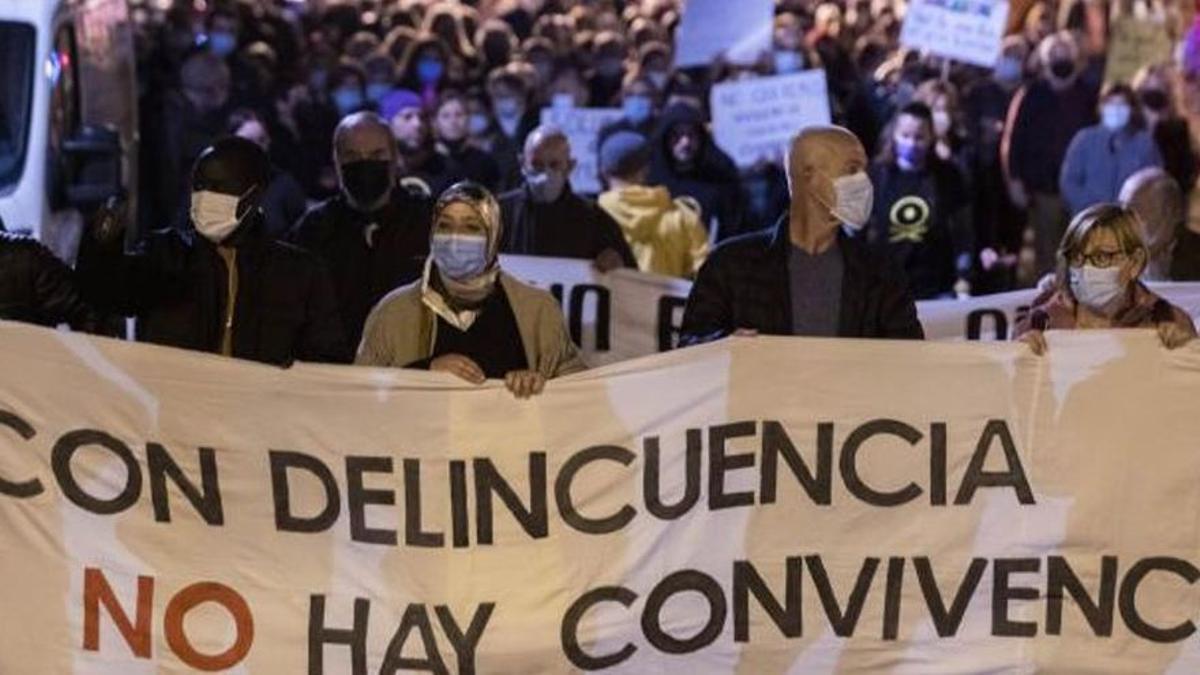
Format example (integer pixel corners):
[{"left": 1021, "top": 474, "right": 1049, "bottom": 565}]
[{"left": 0, "top": 323, "right": 1200, "bottom": 675}]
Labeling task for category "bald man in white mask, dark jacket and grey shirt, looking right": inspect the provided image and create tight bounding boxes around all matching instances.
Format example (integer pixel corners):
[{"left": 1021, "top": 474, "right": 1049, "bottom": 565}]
[{"left": 680, "top": 126, "right": 924, "bottom": 345}]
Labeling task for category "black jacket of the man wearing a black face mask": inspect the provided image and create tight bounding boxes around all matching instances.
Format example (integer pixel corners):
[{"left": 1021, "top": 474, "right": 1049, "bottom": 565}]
[{"left": 289, "top": 186, "right": 433, "bottom": 347}]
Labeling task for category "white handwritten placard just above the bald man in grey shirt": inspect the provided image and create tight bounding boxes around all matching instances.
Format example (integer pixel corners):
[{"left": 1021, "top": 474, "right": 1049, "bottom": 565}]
[{"left": 710, "top": 70, "right": 830, "bottom": 168}]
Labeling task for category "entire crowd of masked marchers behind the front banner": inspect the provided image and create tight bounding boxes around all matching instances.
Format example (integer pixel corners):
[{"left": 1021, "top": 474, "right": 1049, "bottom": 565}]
[{"left": 0, "top": 0, "right": 1200, "bottom": 396}]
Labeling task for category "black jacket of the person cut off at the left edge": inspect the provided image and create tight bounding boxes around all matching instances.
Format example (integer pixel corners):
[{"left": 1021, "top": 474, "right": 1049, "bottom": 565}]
[{"left": 0, "top": 231, "right": 97, "bottom": 330}]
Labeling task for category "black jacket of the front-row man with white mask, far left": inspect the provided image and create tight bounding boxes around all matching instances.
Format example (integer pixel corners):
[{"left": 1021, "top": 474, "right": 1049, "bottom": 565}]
[{"left": 77, "top": 215, "right": 350, "bottom": 365}]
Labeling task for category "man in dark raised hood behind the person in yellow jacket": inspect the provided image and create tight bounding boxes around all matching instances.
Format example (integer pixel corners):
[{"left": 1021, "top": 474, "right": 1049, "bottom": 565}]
[{"left": 649, "top": 103, "right": 744, "bottom": 241}]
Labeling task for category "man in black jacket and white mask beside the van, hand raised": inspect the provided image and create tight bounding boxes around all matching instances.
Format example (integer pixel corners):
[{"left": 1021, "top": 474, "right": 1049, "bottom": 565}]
[{"left": 78, "top": 137, "right": 350, "bottom": 365}]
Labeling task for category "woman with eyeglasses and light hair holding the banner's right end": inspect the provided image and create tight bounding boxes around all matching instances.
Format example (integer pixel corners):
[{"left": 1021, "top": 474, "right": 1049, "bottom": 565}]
[{"left": 1015, "top": 204, "right": 1196, "bottom": 354}]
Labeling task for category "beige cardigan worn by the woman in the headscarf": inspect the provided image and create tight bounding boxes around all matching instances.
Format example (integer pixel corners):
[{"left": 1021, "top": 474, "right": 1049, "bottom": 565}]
[{"left": 354, "top": 273, "right": 587, "bottom": 380}]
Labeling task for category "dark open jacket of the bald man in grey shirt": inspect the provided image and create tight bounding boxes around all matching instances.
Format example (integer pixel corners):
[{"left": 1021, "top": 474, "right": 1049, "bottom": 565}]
[{"left": 679, "top": 215, "right": 924, "bottom": 346}]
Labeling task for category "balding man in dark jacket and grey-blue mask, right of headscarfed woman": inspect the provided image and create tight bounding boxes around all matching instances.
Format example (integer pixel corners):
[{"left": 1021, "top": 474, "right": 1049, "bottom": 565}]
[{"left": 500, "top": 125, "right": 637, "bottom": 271}]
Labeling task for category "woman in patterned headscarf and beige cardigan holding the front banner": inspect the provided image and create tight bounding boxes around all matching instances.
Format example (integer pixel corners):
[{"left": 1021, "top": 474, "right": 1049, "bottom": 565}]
[{"left": 355, "top": 183, "right": 586, "bottom": 399}]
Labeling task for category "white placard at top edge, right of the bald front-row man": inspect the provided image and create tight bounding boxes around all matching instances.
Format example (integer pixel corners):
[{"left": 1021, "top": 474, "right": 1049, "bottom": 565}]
[{"left": 900, "top": 0, "right": 1008, "bottom": 68}]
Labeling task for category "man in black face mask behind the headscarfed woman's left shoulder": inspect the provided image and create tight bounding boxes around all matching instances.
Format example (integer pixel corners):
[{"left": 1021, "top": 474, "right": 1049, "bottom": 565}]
[{"left": 290, "top": 113, "right": 433, "bottom": 345}]
